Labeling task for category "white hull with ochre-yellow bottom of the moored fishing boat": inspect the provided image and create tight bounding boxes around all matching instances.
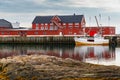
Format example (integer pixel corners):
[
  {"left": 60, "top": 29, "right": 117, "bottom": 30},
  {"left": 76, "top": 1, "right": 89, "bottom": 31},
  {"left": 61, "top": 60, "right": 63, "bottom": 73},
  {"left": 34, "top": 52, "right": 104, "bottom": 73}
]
[{"left": 74, "top": 37, "right": 109, "bottom": 46}]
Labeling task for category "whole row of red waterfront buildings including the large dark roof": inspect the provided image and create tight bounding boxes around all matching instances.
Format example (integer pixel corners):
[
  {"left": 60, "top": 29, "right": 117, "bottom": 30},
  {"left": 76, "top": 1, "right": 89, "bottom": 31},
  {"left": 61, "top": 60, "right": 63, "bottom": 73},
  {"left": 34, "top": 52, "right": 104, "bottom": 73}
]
[{"left": 0, "top": 14, "right": 115, "bottom": 37}]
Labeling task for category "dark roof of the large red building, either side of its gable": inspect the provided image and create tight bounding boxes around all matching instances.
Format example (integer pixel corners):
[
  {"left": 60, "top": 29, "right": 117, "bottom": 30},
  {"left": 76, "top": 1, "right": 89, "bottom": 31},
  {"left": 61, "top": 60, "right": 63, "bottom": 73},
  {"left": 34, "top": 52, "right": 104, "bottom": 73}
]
[{"left": 32, "top": 15, "right": 84, "bottom": 24}]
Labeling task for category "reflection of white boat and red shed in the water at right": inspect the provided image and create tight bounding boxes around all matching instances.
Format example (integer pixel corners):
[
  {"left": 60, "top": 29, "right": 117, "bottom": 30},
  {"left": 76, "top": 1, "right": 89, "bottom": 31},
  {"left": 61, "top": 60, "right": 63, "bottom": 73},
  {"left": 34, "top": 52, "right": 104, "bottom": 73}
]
[{"left": 75, "top": 46, "right": 116, "bottom": 64}]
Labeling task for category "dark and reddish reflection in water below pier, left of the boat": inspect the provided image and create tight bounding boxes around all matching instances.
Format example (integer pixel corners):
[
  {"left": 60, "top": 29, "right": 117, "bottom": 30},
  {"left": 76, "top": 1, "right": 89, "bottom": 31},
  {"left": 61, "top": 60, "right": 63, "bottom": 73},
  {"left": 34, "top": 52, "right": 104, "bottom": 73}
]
[{"left": 0, "top": 44, "right": 74, "bottom": 58}]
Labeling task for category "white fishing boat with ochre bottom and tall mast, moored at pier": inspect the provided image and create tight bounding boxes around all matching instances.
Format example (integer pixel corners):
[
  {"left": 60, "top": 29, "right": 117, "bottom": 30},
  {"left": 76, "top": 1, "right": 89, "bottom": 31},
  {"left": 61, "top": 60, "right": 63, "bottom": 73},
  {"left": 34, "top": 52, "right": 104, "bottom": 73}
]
[{"left": 74, "top": 16, "right": 109, "bottom": 46}]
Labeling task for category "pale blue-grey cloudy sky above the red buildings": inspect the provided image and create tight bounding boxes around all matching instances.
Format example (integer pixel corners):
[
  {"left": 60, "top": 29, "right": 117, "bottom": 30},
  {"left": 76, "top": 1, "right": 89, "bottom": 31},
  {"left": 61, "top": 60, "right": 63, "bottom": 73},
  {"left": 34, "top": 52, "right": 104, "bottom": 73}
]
[{"left": 0, "top": 0, "right": 120, "bottom": 33}]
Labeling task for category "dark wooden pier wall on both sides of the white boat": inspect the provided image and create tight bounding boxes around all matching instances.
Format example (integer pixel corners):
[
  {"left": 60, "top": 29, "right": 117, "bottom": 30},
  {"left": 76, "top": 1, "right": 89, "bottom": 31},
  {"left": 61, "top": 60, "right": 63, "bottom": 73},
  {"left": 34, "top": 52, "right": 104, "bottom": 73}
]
[{"left": 0, "top": 35, "right": 120, "bottom": 46}]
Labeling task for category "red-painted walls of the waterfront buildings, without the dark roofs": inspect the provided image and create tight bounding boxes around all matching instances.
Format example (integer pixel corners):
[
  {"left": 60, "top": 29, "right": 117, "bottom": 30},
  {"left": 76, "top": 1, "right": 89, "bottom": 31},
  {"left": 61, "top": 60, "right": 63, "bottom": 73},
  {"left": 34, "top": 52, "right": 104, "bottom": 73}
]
[{"left": 0, "top": 16, "right": 115, "bottom": 36}]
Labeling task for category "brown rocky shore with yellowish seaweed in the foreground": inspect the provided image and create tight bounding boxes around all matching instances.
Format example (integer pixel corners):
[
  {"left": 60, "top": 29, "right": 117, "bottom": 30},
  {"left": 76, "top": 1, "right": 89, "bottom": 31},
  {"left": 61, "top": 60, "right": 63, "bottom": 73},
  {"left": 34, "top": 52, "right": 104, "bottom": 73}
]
[{"left": 0, "top": 55, "right": 120, "bottom": 80}]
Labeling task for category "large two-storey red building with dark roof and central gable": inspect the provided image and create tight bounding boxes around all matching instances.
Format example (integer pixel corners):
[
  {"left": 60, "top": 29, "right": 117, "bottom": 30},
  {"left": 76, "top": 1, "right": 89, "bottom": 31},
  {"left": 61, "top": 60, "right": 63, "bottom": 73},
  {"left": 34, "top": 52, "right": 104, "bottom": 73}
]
[{"left": 32, "top": 14, "right": 86, "bottom": 35}]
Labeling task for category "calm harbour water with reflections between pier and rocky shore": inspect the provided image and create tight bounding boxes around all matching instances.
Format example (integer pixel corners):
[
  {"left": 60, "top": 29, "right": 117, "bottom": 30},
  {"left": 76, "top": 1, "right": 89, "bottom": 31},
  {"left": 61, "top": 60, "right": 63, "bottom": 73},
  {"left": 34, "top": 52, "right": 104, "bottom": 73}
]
[{"left": 0, "top": 44, "right": 118, "bottom": 65}]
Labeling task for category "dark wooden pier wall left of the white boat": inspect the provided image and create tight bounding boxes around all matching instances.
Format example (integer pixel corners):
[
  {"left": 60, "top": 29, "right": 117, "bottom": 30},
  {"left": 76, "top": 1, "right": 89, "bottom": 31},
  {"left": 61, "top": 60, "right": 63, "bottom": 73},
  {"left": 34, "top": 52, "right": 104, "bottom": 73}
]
[{"left": 0, "top": 36, "right": 75, "bottom": 45}]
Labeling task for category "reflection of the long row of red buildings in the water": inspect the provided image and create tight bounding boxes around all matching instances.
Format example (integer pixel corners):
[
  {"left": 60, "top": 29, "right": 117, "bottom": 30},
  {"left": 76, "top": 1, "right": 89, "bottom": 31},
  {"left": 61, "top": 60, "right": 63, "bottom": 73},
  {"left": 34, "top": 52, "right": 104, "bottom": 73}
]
[{"left": 0, "top": 46, "right": 115, "bottom": 61}]
